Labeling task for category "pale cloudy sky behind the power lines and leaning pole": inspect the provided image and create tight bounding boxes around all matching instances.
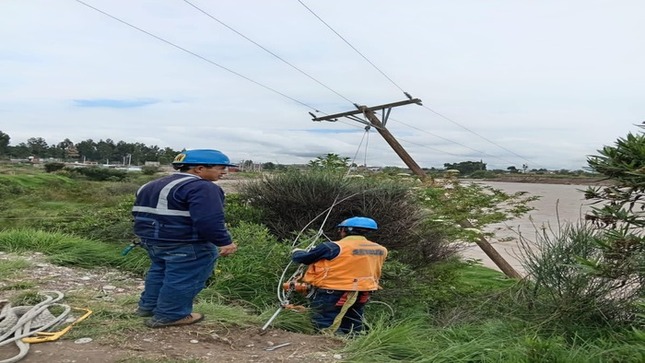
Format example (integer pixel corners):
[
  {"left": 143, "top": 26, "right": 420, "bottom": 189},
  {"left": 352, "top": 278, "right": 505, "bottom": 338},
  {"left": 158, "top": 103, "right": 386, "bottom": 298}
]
[{"left": 0, "top": 0, "right": 645, "bottom": 170}]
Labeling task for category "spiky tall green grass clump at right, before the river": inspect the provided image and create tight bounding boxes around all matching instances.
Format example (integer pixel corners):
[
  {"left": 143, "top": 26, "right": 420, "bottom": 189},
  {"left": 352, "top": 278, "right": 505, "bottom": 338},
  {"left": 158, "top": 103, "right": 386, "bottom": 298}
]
[{"left": 520, "top": 222, "right": 642, "bottom": 330}]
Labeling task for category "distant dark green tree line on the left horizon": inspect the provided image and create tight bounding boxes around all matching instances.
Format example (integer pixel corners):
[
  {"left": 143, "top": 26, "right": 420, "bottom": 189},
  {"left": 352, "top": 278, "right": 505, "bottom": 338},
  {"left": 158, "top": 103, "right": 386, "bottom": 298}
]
[{"left": 0, "top": 131, "right": 181, "bottom": 165}]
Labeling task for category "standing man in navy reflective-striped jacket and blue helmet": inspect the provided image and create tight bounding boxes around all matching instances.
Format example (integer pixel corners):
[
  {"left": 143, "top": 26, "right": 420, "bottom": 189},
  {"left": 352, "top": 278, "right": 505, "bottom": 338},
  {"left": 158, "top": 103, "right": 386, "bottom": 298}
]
[{"left": 132, "top": 149, "right": 237, "bottom": 328}]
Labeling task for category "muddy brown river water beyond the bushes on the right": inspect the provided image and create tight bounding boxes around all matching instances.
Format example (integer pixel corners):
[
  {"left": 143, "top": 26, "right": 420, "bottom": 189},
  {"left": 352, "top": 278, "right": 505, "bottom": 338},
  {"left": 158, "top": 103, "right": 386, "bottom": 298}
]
[{"left": 462, "top": 182, "right": 591, "bottom": 274}]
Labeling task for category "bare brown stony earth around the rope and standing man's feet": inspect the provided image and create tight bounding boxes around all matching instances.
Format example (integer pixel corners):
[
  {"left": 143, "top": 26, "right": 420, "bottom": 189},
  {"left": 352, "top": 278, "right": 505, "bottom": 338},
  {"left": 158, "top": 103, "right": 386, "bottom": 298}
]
[{"left": 0, "top": 252, "right": 343, "bottom": 363}]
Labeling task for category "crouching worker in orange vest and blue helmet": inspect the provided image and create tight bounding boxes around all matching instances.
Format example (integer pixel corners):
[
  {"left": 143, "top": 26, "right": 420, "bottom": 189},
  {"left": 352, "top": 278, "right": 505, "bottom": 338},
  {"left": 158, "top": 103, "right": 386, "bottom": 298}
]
[{"left": 291, "top": 217, "right": 387, "bottom": 334}]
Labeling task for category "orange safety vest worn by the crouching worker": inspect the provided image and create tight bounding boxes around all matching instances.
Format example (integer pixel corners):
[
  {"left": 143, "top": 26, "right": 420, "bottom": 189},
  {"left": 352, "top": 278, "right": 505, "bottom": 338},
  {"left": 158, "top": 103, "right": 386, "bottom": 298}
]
[{"left": 302, "top": 236, "right": 387, "bottom": 291}]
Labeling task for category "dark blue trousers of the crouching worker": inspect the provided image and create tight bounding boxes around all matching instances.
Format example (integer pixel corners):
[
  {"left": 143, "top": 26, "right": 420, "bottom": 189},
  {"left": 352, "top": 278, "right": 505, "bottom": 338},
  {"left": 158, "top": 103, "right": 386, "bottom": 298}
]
[{"left": 311, "top": 289, "right": 369, "bottom": 334}]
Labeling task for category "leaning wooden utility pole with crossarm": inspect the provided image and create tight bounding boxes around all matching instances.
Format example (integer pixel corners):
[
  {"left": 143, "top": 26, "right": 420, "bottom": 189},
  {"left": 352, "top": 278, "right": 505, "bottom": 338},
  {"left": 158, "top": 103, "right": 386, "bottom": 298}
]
[{"left": 309, "top": 98, "right": 522, "bottom": 279}]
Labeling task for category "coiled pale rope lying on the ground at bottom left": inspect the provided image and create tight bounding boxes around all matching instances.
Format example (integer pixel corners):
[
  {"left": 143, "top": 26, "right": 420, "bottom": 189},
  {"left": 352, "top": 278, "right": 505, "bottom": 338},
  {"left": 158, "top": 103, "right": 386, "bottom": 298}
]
[{"left": 0, "top": 291, "right": 71, "bottom": 363}]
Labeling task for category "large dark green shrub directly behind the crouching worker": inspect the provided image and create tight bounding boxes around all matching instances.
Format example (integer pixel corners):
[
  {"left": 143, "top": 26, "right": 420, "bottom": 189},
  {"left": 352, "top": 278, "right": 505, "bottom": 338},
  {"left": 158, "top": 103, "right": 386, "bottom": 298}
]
[{"left": 240, "top": 171, "right": 454, "bottom": 264}]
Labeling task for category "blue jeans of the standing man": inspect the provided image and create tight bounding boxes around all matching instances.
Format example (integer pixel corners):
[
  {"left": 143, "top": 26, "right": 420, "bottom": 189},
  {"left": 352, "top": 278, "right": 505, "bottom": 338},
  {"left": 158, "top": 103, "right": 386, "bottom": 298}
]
[{"left": 139, "top": 240, "right": 218, "bottom": 322}]
